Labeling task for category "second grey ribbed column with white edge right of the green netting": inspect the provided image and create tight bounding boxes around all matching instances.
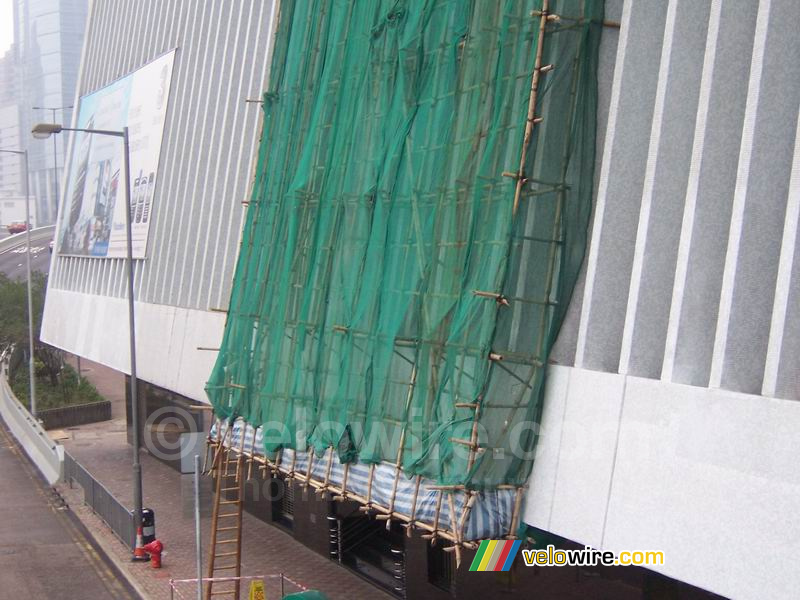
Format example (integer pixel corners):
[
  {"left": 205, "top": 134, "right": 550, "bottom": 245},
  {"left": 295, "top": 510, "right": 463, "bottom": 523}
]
[{"left": 620, "top": 0, "right": 710, "bottom": 378}]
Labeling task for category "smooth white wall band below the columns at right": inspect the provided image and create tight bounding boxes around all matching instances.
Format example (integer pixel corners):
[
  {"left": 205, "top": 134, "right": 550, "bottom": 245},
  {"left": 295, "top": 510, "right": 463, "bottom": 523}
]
[{"left": 523, "top": 367, "right": 800, "bottom": 598}]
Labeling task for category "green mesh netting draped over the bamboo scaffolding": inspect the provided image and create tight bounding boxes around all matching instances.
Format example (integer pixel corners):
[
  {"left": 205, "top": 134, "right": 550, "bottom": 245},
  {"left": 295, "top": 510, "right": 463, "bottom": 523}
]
[{"left": 207, "top": 0, "right": 603, "bottom": 489}]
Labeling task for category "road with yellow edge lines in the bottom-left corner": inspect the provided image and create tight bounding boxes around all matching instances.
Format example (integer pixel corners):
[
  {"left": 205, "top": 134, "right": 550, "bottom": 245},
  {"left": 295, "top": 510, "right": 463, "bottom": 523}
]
[{"left": 0, "top": 421, "right": 139, "bottom": 600}]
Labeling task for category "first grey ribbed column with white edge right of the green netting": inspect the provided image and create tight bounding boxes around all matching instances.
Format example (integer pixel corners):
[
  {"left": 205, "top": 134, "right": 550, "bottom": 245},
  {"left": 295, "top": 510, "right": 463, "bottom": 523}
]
[{"left": 575, "top": 2, "right": 667, "bottom": 372}]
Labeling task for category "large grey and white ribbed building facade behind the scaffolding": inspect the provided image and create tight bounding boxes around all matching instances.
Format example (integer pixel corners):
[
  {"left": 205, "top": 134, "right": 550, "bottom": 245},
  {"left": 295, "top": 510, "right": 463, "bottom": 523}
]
[{"left": 42, "top": 0, "right": 800, "bottom": 598}]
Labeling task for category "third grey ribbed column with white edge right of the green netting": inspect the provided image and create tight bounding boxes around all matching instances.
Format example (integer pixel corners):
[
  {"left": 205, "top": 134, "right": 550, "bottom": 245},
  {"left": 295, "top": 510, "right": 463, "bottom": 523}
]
[{"left": 662, "top": 2, "right": 758, "bottom": 386}]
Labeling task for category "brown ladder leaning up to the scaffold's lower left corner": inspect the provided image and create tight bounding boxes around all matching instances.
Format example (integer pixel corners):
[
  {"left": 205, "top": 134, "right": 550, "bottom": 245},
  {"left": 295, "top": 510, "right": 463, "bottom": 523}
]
[{"left": 204, "top": 420, "right": 246, "bottom": 600}]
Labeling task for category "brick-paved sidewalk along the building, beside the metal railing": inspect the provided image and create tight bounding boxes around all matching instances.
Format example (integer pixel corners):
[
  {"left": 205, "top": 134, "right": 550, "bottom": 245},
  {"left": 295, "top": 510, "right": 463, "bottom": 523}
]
[{"left": 54, "top": 360, "right": 389, "bottom": 600}]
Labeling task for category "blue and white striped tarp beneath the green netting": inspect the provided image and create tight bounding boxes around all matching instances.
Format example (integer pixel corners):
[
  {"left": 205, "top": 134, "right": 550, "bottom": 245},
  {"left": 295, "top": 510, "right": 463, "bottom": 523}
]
[{"left": 211, "top": 419, "right": 516, "bottom": 541}]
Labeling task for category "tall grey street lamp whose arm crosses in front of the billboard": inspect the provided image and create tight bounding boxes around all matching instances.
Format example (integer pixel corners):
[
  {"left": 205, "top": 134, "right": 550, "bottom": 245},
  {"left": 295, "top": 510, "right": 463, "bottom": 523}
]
[{"left": 31, "top": 123, "right": 147, "bottom": 560}]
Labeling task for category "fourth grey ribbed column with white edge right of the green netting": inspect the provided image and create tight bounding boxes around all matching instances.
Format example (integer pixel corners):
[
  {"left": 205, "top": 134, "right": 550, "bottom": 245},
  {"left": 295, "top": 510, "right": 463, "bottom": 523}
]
[{"left": 710, "top": 0, "right": 800, "bottom": 394}]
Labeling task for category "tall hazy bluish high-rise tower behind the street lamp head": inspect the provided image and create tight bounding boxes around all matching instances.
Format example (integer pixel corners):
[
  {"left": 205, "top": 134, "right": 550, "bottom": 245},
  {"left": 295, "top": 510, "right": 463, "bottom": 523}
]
[{"left": 14, "top": 0, "right": 88, "bottom": 224}]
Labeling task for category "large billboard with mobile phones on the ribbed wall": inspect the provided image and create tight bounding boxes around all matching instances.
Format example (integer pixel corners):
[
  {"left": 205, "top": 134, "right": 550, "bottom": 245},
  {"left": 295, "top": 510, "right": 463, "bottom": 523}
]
[{"left": 58, "top": 50, "right": 175, "bottom": 258}]
